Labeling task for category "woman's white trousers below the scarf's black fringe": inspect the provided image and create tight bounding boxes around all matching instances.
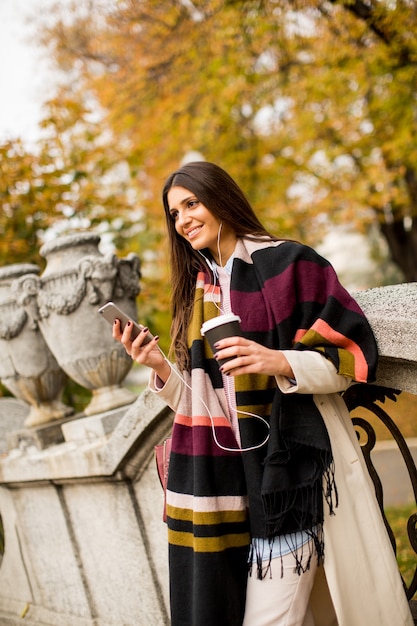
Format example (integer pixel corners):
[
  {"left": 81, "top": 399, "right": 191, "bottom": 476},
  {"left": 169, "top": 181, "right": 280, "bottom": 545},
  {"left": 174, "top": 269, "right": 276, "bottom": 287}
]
[{"left": 243, "top": 554, "right": 317, "bottom": 626}]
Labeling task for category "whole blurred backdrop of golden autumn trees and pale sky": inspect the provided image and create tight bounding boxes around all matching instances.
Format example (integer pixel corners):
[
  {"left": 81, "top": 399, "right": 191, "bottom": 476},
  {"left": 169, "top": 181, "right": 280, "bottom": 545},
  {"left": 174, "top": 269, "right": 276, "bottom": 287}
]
[{"left": 0, "top": 0, "right": 417, "bottom": 366}]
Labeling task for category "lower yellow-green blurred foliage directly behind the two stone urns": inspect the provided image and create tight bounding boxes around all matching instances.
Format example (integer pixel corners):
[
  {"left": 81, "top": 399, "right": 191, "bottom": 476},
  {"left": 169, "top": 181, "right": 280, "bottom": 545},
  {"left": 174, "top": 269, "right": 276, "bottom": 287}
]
[{"left": 0, "top": 90, "right": 147, "bottom": 265}]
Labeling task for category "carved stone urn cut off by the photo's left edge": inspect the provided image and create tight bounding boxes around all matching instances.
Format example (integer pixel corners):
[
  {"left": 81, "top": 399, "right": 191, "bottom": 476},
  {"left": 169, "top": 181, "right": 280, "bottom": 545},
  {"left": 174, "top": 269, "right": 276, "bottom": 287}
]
[{"left": 0, "top": 263, "right": 74, "bottom": 426}]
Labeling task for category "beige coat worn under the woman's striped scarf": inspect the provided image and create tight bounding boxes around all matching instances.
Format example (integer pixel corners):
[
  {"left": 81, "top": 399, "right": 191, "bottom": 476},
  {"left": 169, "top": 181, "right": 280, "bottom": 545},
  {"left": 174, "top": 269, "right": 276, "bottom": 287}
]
[{"left": 149, "top": 350, "right": 414, "bottom": 626}]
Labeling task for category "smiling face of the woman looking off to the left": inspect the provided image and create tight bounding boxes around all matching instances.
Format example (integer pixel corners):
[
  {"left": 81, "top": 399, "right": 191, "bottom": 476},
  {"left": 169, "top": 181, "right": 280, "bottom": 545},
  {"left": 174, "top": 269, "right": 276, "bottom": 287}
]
[{"left": 167, "top": 187, "right": 237, "bottom": 265}]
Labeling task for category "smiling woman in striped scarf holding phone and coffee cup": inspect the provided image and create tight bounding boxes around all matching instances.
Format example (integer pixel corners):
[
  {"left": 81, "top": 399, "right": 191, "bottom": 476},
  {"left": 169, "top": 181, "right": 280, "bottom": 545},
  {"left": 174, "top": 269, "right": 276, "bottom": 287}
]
[{"left": 113, "top": 162, "right": 413, "bottom": 626}]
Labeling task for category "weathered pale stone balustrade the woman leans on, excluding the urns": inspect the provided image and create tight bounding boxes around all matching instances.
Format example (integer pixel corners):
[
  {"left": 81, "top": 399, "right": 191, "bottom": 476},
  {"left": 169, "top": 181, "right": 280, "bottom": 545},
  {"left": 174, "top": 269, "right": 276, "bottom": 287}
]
[{"left": 0, "top": 284, "right": 417, "bottom": 626}]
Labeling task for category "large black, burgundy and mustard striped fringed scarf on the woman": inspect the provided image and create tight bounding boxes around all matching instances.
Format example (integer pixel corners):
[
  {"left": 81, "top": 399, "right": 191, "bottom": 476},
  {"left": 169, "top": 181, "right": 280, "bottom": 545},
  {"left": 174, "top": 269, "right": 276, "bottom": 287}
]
[{"left": 167, "top": 240, "right": 377, "bottom": 626}]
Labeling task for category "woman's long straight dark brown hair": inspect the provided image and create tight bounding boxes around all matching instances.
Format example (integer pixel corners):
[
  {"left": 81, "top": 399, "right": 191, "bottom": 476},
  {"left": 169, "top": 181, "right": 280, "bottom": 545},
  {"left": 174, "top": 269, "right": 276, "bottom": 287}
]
[{"left": 162, "top": 161, "right": 276, "bottom": 369}]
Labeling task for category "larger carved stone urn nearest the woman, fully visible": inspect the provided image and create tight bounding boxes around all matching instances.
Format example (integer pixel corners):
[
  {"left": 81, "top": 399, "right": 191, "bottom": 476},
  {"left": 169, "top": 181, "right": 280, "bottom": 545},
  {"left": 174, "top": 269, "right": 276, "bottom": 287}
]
[{"left": 15, "top": 232, "right": 140, "bottom": 415}]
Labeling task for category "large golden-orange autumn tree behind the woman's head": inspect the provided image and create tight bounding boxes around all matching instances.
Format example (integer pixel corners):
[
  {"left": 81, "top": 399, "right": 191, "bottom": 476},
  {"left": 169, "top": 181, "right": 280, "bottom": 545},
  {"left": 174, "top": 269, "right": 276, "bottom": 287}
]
[{"left": 27, "top": 0, "right": 417, "bottom": 280}]
